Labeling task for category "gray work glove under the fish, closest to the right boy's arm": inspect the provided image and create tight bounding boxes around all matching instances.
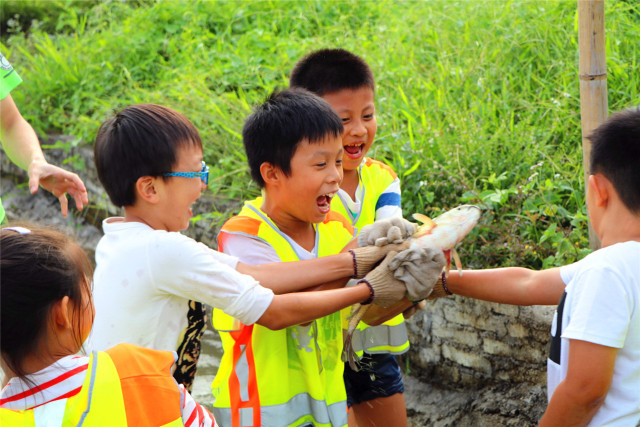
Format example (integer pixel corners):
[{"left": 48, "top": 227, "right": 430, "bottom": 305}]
[{"left": 389, "top": 247, "right": 445, "bottom": 301}]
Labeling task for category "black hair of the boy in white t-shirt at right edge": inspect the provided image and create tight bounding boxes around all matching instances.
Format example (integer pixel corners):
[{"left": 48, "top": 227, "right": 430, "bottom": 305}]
[{"left": 589, "top": 106, "right": 640, "bottom": 215}]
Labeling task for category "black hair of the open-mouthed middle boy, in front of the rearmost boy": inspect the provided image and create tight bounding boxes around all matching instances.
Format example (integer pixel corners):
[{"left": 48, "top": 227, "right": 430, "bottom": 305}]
[{"left": 242, "top": 89, "right": 343, "bottom": 188}]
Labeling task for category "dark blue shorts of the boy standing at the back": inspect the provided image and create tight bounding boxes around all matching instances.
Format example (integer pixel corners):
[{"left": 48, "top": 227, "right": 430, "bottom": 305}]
[{"left": 344, "top": 353, "right": 404, "bottom": 407}]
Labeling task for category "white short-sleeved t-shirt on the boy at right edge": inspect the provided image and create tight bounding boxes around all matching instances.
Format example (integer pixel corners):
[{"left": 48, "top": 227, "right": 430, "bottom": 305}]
[{"left": 547, "top": 242, "right": 640, "bottom": 427}]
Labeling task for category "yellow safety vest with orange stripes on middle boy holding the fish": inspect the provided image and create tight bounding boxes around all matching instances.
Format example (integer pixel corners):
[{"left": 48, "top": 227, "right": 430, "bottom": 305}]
[{"left": 211, "top": 198, "right": 353, "bottom": 427}]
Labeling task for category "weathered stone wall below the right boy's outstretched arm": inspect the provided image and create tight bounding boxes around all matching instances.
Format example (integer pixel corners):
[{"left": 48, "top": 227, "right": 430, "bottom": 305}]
[{"left": 401, "top": 296, "right": 555, "bottom": 426}]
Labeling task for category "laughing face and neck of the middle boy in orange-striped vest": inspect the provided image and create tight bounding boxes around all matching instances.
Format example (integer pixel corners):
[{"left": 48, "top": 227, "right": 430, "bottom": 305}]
[{"left": 268, "top": 136, "right": 343, "bottom": 225}]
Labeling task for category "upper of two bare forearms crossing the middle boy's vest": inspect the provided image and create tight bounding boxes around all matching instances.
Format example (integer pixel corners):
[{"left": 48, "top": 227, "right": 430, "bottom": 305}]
[{"left": 236, "top": 252, "right": 353, "bottom": 294}]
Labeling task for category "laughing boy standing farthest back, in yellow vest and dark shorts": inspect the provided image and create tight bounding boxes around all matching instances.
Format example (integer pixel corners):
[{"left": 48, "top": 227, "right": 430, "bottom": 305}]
[{"left": 289, "top": 49, "right": 410, "bottom": 427}]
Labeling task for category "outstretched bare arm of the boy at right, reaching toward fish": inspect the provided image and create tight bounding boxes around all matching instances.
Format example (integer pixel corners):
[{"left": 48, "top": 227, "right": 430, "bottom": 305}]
[{"left": 447, "top": 267, "right": 564, "bottom": 305}]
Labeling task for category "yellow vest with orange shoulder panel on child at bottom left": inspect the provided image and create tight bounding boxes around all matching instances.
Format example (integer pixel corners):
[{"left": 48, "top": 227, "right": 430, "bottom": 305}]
[{"left": 0, "top": 344, "right": 184, "bottom": 427}]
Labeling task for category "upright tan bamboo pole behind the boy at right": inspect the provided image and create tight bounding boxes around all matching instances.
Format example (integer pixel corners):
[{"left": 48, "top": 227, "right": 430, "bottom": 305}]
[{"left": 578, "top": 0, "right": 609, "bottom": 250}]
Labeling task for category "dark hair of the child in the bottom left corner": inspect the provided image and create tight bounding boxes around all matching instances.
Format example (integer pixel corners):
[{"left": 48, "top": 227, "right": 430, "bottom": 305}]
[{"left": 0, "top": 224, "right": 93, "bottom": 378}]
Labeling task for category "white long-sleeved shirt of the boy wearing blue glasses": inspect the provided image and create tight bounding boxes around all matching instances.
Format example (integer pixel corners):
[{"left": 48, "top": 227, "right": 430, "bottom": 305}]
[{"left": 87, "top": 218, "right": 273, "bottom": 351}]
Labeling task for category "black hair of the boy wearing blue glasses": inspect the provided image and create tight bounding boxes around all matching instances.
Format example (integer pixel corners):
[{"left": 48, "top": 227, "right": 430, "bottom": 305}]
[{"left": 94, "top": 104, "right": 202, "bottom": 207}]
